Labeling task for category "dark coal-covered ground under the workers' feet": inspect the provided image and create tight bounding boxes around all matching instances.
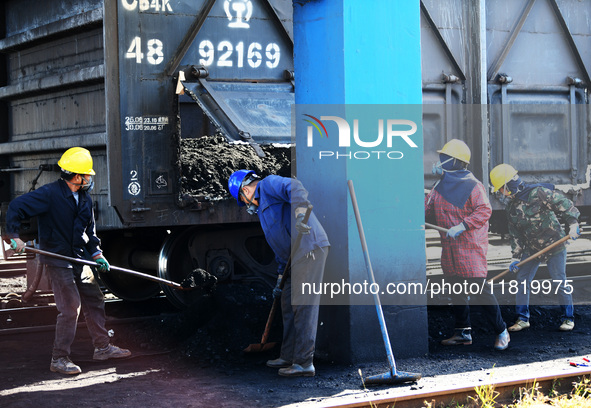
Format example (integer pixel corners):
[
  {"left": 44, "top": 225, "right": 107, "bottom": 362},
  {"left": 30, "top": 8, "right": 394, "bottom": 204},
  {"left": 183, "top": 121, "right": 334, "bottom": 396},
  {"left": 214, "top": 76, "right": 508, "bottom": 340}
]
[{"left": 0, "top": 276, "right": 591, "bottom": 408}]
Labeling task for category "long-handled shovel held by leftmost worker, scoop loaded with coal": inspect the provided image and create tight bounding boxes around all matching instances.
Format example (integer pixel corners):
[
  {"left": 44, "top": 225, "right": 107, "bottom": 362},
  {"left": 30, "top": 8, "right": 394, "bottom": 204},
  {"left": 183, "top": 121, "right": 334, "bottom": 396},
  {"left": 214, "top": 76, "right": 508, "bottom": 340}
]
[{"left": 7, "top": 247, "right": 217, "bottom": 291}]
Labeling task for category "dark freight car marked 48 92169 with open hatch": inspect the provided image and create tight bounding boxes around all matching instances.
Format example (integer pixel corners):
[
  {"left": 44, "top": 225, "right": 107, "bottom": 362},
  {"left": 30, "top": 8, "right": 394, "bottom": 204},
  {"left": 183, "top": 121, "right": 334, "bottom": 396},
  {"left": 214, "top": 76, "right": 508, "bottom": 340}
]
[{"left": 0, "top": 0, "right": 294, "bottom": 307}]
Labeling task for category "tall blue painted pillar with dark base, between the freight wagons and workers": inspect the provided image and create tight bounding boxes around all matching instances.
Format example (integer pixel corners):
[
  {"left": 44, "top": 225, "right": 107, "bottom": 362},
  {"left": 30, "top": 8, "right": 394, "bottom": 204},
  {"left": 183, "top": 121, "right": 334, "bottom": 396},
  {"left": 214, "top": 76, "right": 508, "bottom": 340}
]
[{"left": 293, "top": 0, "right": 428, "bottom": 362}]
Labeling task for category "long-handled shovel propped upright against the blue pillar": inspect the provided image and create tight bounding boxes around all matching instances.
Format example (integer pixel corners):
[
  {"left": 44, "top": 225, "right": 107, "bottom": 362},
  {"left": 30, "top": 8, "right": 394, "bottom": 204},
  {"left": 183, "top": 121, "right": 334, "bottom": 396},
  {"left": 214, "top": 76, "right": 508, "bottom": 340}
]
[{"left": 348, "top": 180, "right": 421, "bottom": 385}]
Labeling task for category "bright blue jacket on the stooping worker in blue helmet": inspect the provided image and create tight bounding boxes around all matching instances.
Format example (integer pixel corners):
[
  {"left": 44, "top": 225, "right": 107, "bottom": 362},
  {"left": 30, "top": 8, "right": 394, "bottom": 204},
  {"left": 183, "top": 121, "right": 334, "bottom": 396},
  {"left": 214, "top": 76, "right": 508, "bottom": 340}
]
[{"left": 254, "top": 176, "right": 330, "bottom": 273}]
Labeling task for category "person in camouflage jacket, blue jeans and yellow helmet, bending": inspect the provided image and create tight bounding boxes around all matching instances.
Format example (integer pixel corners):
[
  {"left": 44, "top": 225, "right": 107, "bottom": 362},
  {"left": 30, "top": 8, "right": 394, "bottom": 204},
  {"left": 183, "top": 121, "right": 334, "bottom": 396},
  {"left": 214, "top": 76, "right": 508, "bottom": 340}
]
[{"left": 490, "top": 164, "right": 580, "bottom": 331}]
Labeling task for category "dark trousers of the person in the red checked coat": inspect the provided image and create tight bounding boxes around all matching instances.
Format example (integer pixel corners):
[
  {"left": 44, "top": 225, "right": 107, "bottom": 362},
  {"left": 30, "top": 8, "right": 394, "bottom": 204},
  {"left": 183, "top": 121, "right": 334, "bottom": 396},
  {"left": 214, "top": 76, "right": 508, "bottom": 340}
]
[{"left": 445, "top": 276, "right": 507, "bottom": 334}]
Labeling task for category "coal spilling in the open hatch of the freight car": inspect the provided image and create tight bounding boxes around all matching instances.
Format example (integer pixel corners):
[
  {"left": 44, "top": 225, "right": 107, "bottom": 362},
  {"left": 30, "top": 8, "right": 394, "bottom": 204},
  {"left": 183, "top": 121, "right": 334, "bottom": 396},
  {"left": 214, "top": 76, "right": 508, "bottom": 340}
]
[{"left": 179, "top": 135, "right": 294, "bottom": 200}]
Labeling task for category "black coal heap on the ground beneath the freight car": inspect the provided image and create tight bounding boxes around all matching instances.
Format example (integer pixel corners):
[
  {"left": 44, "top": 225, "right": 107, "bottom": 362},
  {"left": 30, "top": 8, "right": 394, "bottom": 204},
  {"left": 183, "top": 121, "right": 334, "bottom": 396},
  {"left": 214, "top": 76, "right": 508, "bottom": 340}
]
[{"left": 118, "top": 283, "right": 282, "bottom": 364}]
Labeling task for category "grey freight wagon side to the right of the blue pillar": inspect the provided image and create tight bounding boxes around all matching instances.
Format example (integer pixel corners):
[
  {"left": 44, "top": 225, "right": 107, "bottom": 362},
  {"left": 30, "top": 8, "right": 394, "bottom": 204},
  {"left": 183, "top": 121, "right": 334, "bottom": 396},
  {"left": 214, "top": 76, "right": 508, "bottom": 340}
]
[{"left": 420, "top": 0, "right": 591, "bottom": 232}]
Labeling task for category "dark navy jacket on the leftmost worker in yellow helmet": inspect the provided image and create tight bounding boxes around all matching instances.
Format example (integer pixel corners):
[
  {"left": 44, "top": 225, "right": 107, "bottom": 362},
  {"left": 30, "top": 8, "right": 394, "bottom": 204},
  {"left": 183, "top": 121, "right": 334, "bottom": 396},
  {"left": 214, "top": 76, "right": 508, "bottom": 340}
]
[{"left": 5, "top": 179, "right": 101, "bottom": 268}]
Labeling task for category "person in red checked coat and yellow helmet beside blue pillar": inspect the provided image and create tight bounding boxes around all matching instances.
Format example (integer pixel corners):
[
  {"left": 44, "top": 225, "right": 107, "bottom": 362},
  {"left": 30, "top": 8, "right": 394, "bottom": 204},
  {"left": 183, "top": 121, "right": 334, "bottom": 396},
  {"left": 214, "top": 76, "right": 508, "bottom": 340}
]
[{"left": 425, "top": 139, "right": 510, "bottom": 350}]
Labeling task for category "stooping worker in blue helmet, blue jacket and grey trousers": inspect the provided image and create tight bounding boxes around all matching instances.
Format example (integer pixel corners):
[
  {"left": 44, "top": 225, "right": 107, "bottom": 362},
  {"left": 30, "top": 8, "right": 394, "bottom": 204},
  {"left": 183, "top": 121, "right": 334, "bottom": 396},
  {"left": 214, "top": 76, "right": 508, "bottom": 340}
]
[{"left": 228, "top": 170, "right": 330, "bottom": 377}]
